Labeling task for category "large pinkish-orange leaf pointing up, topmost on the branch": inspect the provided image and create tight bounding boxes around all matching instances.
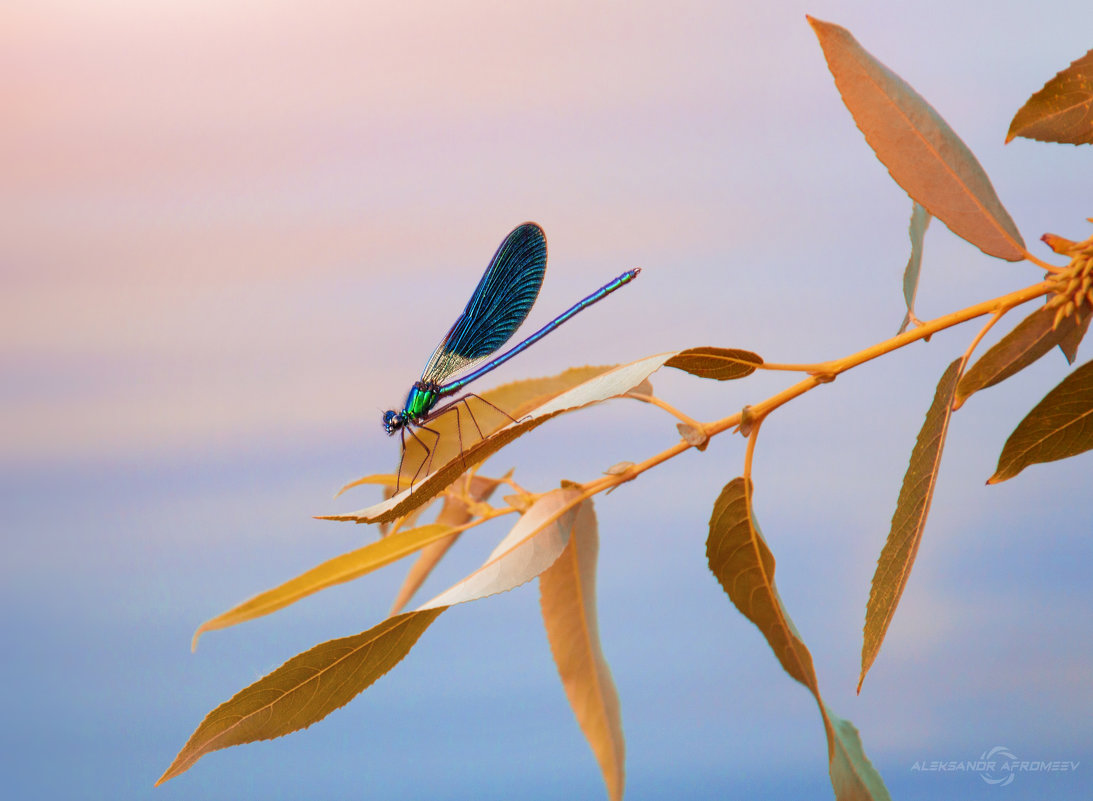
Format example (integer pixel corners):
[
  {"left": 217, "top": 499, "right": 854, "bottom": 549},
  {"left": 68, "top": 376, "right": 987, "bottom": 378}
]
[{"left": 808, "top": 16, "right": 1025, "bottom": 261}]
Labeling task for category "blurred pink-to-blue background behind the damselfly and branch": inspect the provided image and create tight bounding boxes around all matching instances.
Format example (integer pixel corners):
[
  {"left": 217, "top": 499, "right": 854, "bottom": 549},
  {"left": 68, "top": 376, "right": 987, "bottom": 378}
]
[{"left": 0, "top": 0, "right": 1093, "bottom": 801}]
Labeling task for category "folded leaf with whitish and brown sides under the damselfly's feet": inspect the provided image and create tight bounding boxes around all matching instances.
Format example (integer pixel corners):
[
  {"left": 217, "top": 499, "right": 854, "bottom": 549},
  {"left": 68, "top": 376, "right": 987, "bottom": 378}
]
[{"left": 319, "top": 352, "right": 675, "bottom": 523}]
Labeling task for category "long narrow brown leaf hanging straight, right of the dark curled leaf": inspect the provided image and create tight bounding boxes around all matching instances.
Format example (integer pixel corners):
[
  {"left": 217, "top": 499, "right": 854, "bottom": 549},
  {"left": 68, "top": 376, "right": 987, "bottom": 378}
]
[{"left": 858, "top": 358, "right": 963, "bottom": 693}]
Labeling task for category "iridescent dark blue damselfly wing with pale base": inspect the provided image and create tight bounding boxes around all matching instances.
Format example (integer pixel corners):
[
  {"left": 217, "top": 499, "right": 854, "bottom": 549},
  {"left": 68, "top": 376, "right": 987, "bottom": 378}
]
[{"left": 421, "top": 223, "right": 547, "bottom": 384}]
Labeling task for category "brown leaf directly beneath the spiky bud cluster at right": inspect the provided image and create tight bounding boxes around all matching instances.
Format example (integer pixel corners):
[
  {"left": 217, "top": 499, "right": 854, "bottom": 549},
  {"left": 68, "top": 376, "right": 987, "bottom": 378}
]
[{"left": 954, "top": 306, "right": 1089, "bottom": 409}]
